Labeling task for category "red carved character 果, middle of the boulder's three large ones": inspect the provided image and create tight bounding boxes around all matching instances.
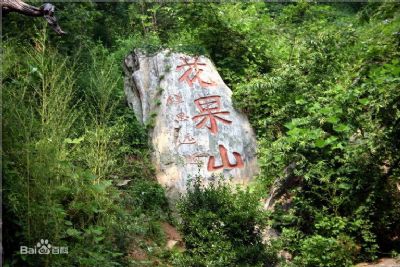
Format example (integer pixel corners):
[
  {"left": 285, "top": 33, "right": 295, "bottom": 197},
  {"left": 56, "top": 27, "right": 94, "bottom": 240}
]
[{"left": 192, "top": 95, "right": 232, "bottom": 134}]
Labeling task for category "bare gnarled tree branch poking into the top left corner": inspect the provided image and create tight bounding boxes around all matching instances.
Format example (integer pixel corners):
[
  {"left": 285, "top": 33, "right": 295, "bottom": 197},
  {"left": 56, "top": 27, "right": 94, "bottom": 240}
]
[{"left": 0, "top": 0, "right": 66, "bottom": 35}]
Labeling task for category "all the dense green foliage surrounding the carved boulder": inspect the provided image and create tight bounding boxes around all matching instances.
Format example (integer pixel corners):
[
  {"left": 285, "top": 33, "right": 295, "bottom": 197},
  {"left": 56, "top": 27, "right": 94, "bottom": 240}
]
[{"left": 2, "top": 1, "right": 400, "bottom": 266}]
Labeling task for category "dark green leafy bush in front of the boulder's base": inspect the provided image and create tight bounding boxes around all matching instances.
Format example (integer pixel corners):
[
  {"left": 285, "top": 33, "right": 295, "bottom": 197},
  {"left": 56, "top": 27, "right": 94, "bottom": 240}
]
[{"left": 177, "top": 176, "right": 274, "bottom": 267}]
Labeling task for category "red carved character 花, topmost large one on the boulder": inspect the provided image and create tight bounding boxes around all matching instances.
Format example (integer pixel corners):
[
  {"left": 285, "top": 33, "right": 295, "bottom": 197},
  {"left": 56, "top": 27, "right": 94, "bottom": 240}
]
[{"left": 176, "top": 57, "right": 216, "bottom": 87}]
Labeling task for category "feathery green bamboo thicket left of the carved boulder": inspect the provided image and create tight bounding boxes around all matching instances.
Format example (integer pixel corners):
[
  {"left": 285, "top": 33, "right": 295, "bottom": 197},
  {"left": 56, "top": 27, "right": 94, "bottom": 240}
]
[{"left": 3, "top": 26, "right": 169, "bottom": 266}]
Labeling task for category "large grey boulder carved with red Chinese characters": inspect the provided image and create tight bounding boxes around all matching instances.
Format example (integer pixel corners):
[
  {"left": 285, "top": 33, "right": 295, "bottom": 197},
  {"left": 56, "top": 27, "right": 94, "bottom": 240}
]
[{"left": 125, "top": 51, "right": 258, "bottom": 198}]
